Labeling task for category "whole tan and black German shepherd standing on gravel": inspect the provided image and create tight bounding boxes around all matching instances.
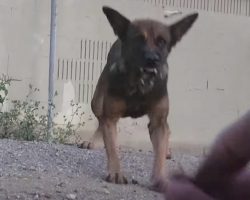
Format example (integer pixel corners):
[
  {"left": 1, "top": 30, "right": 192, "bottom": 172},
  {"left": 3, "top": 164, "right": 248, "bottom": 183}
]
[{"left": 83, "top": 6, "right": 198, "bottom": 190}]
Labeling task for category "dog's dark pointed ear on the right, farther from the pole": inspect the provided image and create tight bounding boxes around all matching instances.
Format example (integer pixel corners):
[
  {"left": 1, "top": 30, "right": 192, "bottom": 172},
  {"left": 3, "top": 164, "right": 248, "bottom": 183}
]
[{"left": 170, "top": 13, "right": 198, "bottom": 47}]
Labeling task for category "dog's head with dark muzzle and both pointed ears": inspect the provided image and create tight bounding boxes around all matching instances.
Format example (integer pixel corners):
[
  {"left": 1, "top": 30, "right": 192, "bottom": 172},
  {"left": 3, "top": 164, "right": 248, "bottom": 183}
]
[{"left": 103, "top": 7, "right": 198, "bottom": 93}]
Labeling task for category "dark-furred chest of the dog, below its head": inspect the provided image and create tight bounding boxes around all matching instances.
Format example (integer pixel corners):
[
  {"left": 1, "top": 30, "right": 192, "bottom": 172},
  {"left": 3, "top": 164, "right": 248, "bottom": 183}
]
[{"left": 108, "top": 62, "right": 167, "bottom": 118}]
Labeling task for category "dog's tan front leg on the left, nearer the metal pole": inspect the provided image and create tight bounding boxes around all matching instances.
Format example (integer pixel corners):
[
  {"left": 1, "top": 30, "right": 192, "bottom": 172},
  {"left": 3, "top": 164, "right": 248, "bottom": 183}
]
[{"left": 103, "top": 119, "right": 127, "bottom": 184}]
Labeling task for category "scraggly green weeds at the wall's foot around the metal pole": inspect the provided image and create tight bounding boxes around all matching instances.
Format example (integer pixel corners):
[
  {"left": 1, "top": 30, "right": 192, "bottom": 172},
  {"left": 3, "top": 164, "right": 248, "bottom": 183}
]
[{"left": 0, "top": 80, "right": 84, "bottom": 143}]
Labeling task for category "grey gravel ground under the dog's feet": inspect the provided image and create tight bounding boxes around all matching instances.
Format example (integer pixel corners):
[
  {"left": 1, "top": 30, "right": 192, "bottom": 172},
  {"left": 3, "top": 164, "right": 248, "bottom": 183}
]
[{"left": 0, "top": 140, "right": 202, "bottom": 200}]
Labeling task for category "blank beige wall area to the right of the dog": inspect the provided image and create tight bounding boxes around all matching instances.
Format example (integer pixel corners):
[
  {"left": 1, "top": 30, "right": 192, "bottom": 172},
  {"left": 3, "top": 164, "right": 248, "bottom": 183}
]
[{"left": 169, "top": 10, "right": 250, "bottom": 143}]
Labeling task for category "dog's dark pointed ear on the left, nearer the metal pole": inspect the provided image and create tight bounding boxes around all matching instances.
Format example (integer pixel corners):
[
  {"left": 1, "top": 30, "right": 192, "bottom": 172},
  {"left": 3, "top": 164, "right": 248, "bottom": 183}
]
[{"left": 102, "top": 6, "right": 130, "bottom": 40}]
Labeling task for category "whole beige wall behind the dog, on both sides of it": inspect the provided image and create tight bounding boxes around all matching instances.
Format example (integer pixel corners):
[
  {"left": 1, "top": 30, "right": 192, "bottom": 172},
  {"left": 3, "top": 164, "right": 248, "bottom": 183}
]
[{"left": 0, "top": 0, "right": 250, "bottom": 147}]
